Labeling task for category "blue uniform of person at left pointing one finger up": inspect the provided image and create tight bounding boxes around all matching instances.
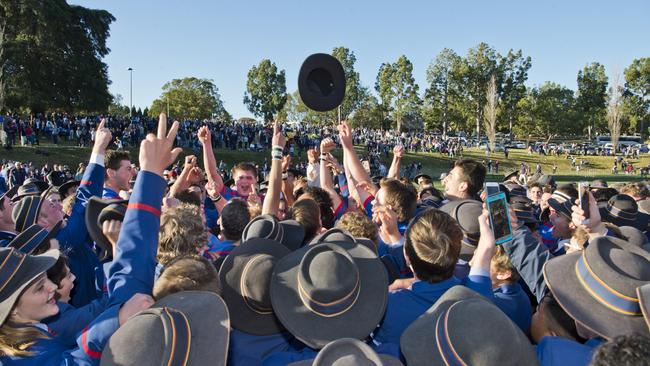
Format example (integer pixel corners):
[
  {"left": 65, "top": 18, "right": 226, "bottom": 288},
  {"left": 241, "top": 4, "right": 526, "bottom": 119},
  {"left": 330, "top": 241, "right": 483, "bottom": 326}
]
[{"left": 56, "top": 163, "right": 105, "bottom": 308}]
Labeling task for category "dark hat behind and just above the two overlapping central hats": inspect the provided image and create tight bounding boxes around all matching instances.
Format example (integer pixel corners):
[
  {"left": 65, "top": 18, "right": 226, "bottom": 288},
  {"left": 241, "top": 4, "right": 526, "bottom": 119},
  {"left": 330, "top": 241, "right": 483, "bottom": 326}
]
[{"left": 242, "top": 215, "right": 305, "bottom": 250}]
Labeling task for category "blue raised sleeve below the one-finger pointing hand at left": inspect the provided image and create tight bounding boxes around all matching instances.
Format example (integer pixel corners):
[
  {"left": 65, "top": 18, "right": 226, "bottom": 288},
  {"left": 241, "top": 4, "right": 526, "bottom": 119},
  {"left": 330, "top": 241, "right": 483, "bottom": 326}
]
[{"left": 56, "top": 164, "right": 104, "bottom": 250}]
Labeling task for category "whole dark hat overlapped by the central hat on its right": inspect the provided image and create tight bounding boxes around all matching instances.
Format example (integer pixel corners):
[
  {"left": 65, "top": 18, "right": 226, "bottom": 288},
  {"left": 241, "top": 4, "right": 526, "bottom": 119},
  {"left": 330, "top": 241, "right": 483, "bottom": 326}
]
[{"left": 219, "top": 238, "right": 291, "bottom": 336}]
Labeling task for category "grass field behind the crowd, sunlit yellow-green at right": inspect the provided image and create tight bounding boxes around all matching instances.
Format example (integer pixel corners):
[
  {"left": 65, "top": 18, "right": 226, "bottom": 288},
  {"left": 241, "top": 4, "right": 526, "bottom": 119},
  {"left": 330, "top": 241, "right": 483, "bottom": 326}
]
[{"left": 0, "top": 142, "right": 650, "bottom": 186}]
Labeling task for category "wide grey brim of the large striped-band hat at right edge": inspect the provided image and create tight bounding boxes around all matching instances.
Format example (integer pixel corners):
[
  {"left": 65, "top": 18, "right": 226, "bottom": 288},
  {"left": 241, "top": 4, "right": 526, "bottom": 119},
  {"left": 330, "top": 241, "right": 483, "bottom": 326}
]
[{"left": 543, "top": 253, "right": 647, "bottom": 339}]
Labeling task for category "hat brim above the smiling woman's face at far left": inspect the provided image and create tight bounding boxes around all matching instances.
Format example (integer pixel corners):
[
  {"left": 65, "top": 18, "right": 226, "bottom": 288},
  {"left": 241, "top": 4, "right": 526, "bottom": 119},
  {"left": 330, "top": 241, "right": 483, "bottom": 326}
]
[{"left": 0, "top": 249, "right": 60, "bottom": 326}]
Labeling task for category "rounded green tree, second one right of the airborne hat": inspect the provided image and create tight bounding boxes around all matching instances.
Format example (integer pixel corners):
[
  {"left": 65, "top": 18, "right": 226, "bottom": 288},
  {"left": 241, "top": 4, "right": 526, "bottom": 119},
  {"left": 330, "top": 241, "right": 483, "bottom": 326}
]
[{"left": 375, "top": 55, "right": 421, "bottom": 131}]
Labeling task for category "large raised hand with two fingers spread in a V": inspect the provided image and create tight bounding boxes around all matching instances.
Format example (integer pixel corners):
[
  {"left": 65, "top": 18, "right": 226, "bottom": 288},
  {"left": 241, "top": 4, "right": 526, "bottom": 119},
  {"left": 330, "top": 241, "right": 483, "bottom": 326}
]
[{"left": 139, "top": 113, "right": 183, "bottom": 177}]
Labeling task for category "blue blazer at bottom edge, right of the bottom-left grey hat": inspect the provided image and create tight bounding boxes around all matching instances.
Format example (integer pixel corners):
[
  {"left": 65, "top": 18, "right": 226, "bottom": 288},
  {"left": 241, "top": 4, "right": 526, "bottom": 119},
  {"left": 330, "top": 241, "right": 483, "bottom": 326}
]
[{"left": 228, "top": 329, "right": 305, "bottom": 366}]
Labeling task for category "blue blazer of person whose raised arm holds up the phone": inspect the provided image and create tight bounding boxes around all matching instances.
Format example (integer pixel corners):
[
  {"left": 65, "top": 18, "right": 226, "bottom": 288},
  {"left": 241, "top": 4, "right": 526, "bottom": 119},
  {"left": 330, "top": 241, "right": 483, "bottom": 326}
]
[{"left": 372, "top": 268, "right": 493, "bottom": 345}]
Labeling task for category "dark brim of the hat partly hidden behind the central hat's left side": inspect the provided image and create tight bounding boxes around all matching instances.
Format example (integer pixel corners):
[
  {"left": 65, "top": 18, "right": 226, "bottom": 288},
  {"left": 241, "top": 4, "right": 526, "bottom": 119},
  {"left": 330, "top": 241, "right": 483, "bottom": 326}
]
[{"left": 219, "top": 238, "right": 290, "bottom": 335}]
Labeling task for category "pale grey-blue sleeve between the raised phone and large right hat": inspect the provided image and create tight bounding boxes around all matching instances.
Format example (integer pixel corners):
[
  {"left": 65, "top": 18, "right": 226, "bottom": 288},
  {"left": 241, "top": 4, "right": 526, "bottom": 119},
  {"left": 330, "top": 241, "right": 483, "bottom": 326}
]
[{"left": 501, "top": 226, "right": 553, "bottom": 302}]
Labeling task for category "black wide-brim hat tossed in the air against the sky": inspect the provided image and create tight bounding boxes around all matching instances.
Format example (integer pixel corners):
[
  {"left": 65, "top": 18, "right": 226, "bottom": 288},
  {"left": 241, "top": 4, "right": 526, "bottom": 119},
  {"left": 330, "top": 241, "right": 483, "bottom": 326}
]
[{"left": 298, "top": 53, "right": 346, "bottom": 112}]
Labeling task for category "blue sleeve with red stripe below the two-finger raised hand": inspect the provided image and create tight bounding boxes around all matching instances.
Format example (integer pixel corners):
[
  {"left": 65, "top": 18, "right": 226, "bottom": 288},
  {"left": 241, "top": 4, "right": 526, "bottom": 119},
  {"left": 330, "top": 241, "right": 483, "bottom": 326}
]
[{"left": 108, "top": 171, "right": 166, "bottom": 305}]
